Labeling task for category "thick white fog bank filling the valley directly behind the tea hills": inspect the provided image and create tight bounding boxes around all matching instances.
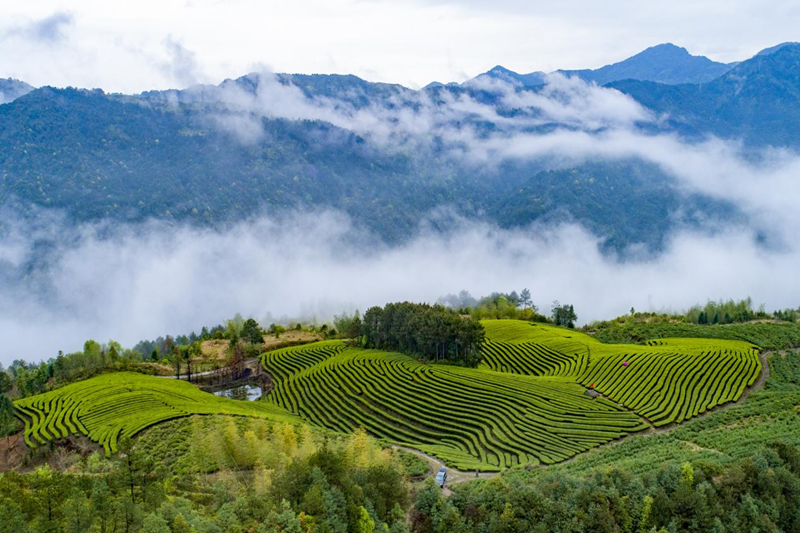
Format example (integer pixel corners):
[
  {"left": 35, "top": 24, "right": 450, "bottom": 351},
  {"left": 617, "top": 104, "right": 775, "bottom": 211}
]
[{"left": 0, "top": 202, "right": 800, "bottom": 364}]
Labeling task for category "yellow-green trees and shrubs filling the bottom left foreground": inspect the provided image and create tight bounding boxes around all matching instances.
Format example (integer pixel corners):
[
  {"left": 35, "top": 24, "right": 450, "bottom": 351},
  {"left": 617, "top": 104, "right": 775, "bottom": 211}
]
[{"left": 0, "top": 417, "right": 410, "bottom": 533}]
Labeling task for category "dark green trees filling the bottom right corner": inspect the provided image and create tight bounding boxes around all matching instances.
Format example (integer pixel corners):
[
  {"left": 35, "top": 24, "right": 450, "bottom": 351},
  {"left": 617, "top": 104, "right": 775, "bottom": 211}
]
[{"left": 411, "top": 443, "right": 800, "bottom": 533}]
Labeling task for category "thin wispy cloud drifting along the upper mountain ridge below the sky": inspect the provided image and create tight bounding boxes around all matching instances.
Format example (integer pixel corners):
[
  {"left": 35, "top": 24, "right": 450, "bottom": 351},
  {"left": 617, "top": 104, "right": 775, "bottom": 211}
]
[{"left": 168, "top": 71, "right": 659, "bottom": 155}]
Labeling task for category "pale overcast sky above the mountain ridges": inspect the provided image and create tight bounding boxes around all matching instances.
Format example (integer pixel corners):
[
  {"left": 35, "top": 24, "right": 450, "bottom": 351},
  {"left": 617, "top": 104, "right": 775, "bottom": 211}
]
[{"left": 0, "top": 0, "right": 800, "bottom": 93}]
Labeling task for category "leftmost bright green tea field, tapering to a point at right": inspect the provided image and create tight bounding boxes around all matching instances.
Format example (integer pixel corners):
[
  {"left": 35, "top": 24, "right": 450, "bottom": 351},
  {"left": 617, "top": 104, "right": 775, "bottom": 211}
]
[{"left": 14, "top": 372, "right": 297, "bottom": 454}]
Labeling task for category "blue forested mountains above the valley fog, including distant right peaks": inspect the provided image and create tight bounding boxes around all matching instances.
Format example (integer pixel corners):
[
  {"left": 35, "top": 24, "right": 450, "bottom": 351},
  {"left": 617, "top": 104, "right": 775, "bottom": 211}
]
[{"left": 0, "top": 44, "right": 800, "bottom": 249}]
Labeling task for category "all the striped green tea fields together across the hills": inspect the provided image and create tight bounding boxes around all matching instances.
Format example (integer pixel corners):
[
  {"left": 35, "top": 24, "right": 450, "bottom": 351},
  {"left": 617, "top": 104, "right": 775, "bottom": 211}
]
[{"left": 15, "top": 320, "right": 761, "bottom": 470}]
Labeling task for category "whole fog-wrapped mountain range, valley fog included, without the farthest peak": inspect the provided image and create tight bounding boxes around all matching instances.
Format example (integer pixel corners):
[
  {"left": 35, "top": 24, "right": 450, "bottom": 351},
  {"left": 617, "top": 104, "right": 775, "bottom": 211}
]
[{"left": 0, "top": 44, "right": 800, "bottom": 360}]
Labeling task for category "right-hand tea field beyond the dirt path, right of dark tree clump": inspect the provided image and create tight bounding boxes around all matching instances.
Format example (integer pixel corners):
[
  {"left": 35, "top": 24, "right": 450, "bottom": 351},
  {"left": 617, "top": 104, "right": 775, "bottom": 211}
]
[{"left": 484, "top": 320, "right": 761, "bottom": 426}]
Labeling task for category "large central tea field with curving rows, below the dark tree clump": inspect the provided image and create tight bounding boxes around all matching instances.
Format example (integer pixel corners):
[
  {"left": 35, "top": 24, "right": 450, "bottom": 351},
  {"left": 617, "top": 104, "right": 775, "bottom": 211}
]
[{"left": 263, "top": 342, "right": 644, "bottom": 470}]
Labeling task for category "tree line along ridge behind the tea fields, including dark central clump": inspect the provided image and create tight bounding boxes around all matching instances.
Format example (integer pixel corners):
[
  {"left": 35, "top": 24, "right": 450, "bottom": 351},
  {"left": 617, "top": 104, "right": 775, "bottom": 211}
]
[{"left": 0, "top": 289, "right": 577, "bottom": 398}]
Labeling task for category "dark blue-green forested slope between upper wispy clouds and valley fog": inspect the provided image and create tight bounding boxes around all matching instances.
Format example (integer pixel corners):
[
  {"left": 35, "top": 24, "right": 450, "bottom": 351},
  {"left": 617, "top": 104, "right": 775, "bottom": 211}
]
[{"left": 0, "top": 85, "right": 731, "bottom": 246}]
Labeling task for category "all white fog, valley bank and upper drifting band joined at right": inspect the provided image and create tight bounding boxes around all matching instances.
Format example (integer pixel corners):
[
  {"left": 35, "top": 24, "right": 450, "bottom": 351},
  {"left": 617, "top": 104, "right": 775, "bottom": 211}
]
[{"left": 0, "top": 76, "right": 800, "bottom": 363}]
